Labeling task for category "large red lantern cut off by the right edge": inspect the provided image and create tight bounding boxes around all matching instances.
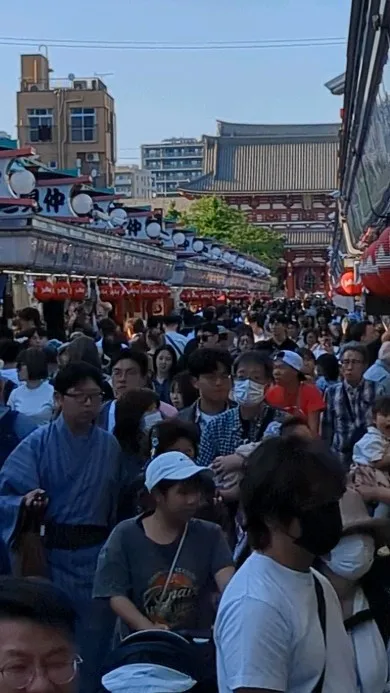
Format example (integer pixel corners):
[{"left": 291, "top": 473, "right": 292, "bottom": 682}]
[{"left": 360, "top": 227, "right": 390, "bottom": 297}]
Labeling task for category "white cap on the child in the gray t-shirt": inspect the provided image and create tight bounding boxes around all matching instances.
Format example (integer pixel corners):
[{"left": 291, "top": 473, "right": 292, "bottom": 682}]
[{"left": 145, "top": 451, "right": 205, "bottom": 491}]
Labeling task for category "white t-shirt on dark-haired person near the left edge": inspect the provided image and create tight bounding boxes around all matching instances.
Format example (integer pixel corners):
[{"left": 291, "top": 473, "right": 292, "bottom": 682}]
[{"left": 8, "top": 380, "right": 54, "bottom": 426}]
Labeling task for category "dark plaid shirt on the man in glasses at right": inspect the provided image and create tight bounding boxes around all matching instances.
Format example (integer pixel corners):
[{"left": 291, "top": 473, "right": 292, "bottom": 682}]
[{"left": 322, "top": 380, "right": 383, "bottom": 469}]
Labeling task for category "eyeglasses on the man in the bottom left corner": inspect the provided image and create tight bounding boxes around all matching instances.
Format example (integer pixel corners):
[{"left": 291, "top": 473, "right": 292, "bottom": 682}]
[{"left": 0, "top": 655, "right": 83, "bottom": 691}]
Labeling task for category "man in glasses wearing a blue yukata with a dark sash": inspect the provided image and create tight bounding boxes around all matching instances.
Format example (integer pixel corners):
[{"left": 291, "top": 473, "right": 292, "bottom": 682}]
[{"left": 0, "top": 362, "right": 121, "bottom": 693}]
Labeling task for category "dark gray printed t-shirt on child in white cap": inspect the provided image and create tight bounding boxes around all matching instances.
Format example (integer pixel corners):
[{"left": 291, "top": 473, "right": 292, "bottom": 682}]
[{"left": 93, "top": 517, "right": 233, "bottom": 630}]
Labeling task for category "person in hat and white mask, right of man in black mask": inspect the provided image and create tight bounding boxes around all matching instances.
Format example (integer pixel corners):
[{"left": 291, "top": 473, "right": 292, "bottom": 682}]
[{"left": 317, "top": 490, "right": 390, "bottom": 693}]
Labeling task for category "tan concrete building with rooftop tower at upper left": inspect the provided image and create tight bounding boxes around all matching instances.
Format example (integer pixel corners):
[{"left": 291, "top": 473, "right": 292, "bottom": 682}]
[{"left": 17, "top": 54, "right": 116, "bottom": 187}]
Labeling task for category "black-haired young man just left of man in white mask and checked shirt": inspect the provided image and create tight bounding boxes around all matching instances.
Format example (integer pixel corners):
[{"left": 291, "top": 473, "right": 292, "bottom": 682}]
[{"left": 179, "top": 347, "right": 236, "bottom": 431}]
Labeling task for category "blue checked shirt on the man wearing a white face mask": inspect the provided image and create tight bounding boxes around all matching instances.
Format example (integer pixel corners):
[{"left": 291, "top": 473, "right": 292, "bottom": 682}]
[{"left": 198, "top": 404, "right": 286, "bottom": 467}]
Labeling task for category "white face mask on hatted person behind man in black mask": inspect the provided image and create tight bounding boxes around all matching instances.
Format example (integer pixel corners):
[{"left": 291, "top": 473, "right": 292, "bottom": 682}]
[{"left": 322, "top": 534, "right": 375, "bottom": 581}]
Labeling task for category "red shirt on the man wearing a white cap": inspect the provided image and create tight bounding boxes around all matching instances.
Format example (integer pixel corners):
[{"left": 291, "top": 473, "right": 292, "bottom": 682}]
[{"left": 265, "top": 383, "right": 325, "bottom": 416}]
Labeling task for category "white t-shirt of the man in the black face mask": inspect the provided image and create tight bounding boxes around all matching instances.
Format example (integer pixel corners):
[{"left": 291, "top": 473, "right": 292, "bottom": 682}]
[{"left": 214, "top": 553, "right": 358, "bottom": 693}]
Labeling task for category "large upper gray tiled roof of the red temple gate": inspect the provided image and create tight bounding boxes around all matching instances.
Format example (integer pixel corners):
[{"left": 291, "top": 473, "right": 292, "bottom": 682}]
[{"left": 179, "top": 135, "right": 338, "bottom": 194}]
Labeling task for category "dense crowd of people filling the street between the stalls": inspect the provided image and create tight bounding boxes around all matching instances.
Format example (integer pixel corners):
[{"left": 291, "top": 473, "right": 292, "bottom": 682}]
[{"left": 0, "top": 297, "right": 390, "bottom": 693}]
